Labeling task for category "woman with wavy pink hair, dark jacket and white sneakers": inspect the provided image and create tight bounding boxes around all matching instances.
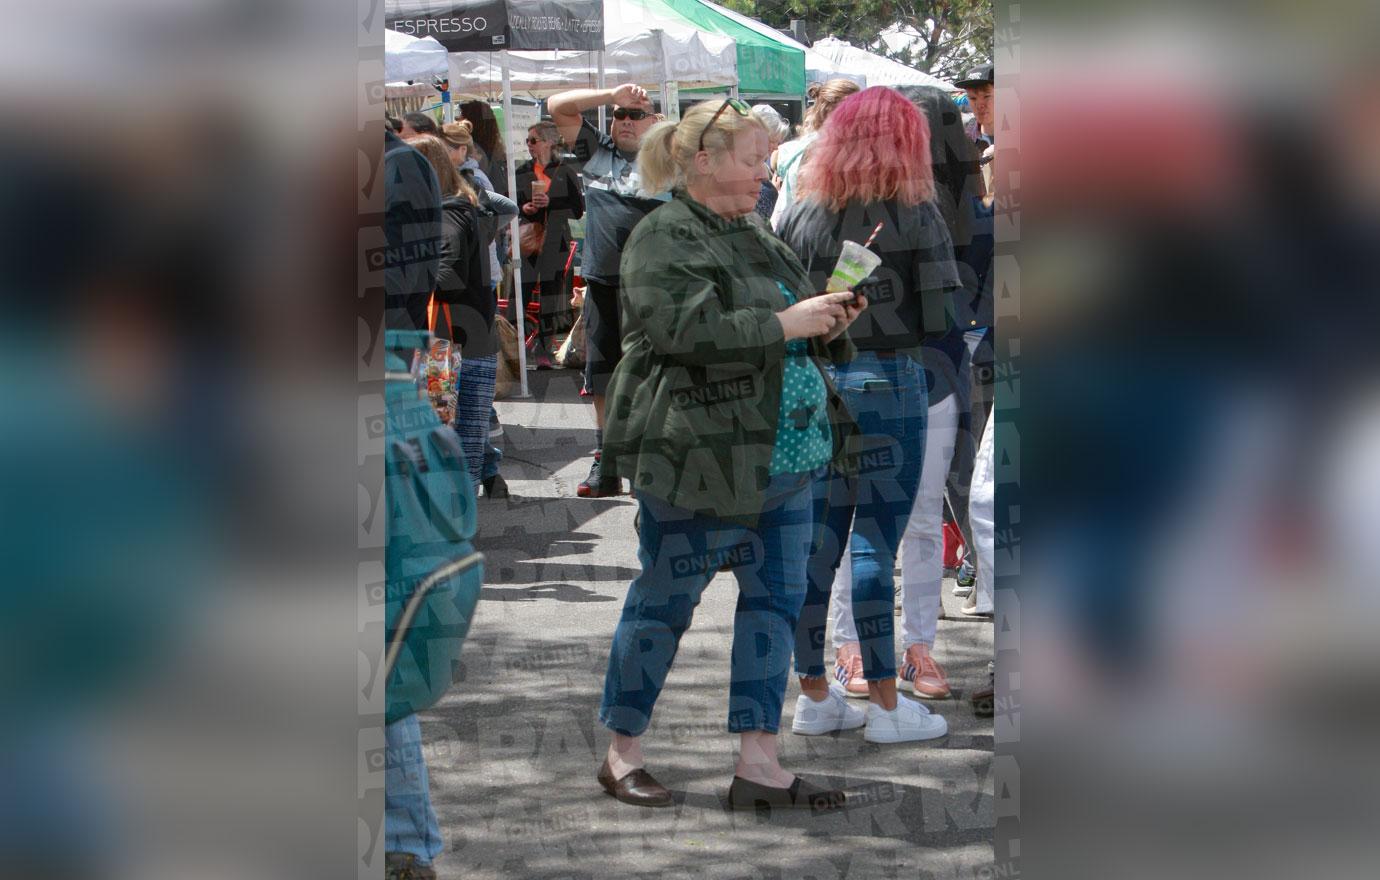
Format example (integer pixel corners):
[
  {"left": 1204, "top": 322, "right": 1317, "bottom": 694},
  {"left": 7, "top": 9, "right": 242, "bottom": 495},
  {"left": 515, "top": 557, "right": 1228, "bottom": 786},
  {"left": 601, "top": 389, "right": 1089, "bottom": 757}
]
[{"left": 778, "top": 87, "right": 960, "bottom": 742}]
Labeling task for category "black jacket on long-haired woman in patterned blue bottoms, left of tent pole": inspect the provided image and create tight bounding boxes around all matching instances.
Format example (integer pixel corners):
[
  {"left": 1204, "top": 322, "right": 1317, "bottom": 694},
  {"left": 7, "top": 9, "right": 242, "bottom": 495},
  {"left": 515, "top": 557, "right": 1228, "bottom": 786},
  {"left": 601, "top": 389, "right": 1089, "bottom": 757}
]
[{"left": 436, "top": 196, "right": 498, "bottom": 357}]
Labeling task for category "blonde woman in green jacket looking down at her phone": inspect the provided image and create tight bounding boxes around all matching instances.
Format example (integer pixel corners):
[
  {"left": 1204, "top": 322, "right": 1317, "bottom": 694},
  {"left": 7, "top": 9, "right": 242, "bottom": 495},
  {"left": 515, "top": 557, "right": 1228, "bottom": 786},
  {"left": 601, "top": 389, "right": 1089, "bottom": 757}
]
[{"left": 598, "top": 99, "right": 865, "bottom": 810}]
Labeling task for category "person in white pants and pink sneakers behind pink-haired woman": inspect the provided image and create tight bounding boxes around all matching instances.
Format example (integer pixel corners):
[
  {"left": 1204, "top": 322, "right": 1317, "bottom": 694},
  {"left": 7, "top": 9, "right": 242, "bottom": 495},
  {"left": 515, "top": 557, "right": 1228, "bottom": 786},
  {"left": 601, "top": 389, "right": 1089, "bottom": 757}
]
[{"left": 829, "top": 331, "right": 963, "bottom": 699}]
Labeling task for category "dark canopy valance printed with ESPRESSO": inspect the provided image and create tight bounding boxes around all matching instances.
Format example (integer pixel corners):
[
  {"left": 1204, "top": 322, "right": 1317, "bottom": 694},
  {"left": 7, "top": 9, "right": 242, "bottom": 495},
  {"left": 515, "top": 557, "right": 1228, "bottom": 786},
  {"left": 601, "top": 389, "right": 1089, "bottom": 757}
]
[{"left": 384, "top": 0, "right": 603, "bottom": 52}]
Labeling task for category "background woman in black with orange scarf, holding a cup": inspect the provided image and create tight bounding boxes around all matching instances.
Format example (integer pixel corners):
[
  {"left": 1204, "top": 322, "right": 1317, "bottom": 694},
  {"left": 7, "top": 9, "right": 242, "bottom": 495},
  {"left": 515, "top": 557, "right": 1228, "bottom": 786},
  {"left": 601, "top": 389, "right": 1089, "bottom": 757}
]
[{"left": 516, "top": 120, "right": 585, "bottom": 370}]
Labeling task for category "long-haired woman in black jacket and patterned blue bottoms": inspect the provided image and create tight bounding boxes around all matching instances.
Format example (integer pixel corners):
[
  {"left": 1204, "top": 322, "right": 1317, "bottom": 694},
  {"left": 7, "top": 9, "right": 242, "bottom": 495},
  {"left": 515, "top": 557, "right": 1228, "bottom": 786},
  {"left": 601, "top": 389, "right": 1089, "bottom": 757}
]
[{"left": 408, "top": 135, "right": 498, "bottom": 491}]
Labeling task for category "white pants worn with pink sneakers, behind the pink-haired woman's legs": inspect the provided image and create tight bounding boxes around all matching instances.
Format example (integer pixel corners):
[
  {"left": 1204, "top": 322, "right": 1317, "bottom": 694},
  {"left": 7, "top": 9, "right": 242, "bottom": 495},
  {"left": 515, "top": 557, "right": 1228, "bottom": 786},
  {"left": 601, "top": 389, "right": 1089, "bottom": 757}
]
[{"left": 829, "top": 394, "right": 959, "bottom": 652}]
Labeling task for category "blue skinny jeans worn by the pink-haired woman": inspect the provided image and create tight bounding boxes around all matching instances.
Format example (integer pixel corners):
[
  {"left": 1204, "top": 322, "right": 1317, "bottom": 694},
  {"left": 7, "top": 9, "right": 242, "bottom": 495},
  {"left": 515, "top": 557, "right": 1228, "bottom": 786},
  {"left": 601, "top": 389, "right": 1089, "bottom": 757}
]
[{"left": 795, "top": 352, "right": 929, "bottom": 681}]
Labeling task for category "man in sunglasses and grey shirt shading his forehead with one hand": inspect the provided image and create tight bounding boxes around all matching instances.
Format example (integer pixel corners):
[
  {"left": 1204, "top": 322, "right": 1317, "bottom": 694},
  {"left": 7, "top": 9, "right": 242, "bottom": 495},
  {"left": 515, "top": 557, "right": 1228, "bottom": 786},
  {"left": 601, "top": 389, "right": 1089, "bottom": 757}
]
[{"left": 546, "top": 83, "right": 671, "bottom": 498}]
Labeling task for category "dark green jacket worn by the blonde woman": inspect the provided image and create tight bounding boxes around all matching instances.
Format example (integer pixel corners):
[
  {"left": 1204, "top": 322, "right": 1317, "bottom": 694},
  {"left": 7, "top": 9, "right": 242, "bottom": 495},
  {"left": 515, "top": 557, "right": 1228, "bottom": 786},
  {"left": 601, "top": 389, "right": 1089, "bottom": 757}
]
[{"left": 602, "top": 192, "right": 854, "bottom": 526}]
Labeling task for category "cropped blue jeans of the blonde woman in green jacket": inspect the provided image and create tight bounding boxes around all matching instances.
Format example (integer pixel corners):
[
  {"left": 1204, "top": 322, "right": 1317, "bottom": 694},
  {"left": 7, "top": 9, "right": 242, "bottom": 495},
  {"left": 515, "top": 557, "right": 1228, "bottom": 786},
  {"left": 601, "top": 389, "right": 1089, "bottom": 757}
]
[{"left": 599, "top": 473, "right": 818, "bottom": 737}]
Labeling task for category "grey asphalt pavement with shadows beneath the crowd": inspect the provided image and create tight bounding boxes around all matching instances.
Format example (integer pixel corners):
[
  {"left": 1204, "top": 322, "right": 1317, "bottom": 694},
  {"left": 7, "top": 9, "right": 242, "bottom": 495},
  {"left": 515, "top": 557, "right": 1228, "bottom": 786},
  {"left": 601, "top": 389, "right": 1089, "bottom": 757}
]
[{"left": 421, "top": 370, "right": 995, "bottom": 880}]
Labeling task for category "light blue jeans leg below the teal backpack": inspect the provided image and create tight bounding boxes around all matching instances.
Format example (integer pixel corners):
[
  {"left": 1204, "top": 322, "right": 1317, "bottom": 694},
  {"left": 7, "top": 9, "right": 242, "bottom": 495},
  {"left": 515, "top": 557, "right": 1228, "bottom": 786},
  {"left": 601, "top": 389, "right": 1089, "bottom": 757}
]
[{"left": 384, "top": 714, "right": 444, "bottom": 865}]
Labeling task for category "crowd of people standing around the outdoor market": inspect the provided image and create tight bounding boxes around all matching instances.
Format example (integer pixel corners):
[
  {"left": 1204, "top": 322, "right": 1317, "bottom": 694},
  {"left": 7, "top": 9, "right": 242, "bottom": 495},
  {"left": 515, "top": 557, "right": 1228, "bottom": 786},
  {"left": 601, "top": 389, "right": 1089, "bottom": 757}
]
[{"left": 386, "top": 65, "right": 995, "bottom": 876}]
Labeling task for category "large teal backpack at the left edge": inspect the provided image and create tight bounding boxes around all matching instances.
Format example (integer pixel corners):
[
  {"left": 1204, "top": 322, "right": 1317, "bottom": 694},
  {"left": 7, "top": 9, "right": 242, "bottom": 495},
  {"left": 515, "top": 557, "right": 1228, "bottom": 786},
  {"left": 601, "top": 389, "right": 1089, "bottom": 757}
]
[{"left": 384, "top": 330, "right": 484, "bottom": 724}]
